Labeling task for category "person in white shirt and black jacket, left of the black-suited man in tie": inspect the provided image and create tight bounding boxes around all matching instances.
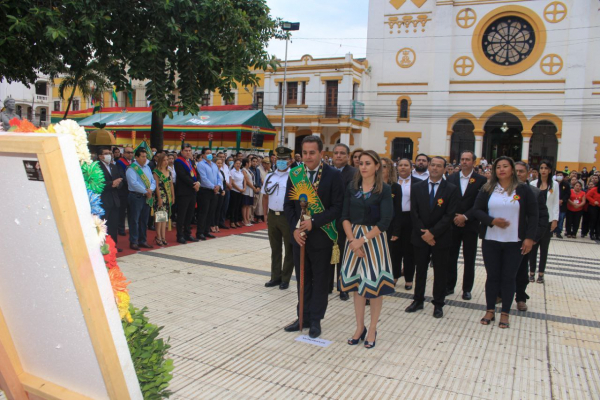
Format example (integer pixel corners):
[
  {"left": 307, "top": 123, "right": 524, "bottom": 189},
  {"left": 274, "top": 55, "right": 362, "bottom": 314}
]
[{"left": 392, "top": 158, "right": 422, "bottom": 290}]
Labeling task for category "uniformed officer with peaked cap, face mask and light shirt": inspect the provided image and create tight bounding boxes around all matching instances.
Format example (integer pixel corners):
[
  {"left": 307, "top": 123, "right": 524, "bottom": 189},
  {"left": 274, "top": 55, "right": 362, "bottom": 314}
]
[{"left": 262, "top": 146, "right": 294, "bottom": 290}]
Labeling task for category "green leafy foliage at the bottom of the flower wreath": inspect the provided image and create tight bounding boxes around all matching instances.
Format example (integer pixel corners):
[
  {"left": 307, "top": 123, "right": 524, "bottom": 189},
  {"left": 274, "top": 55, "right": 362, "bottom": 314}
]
[{"left": 123, "top": 305, "right": 173, "bottom": 400}]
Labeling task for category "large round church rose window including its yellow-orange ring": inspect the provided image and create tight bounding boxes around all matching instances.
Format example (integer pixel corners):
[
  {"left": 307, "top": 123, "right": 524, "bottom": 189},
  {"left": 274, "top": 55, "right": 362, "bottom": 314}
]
[{"left": 472, "top": 6, "right": 546, "bottom": 76}]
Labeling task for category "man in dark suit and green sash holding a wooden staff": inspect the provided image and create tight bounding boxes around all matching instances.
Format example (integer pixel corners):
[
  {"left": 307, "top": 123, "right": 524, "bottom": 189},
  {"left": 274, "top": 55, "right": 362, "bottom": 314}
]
[{"left": 283, "top": 135, "right": 344, "bottom": 338}]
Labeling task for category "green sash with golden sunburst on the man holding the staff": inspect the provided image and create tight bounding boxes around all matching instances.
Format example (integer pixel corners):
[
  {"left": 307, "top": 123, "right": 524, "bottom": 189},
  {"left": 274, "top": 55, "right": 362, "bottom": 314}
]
[{"left": 290, "top": 165, "right": 340, "bottom": 264}]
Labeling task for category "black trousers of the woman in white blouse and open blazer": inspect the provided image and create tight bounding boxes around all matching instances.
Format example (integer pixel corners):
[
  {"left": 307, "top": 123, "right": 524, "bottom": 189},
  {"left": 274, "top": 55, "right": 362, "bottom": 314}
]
[{"left": 481, "top": 240, "right": 523, "bottom": 313}]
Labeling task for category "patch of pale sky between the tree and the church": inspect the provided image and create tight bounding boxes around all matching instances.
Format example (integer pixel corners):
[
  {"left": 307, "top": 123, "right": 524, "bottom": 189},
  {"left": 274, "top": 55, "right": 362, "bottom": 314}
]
[{"left": 267, "top": 0, "right": 369, "bottom": 60}]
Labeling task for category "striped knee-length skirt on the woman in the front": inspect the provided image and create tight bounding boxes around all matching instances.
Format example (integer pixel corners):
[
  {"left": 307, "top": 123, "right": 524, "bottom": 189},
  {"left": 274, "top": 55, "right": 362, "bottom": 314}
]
[{"left": 341, "top": 224, "right": 395, "bottom": 298}]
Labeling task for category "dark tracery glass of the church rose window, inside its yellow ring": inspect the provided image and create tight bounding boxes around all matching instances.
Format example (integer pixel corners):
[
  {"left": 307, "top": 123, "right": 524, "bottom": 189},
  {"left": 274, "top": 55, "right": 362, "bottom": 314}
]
[{"left": 481, "top": 16, "right": 535, "bottom": 66}]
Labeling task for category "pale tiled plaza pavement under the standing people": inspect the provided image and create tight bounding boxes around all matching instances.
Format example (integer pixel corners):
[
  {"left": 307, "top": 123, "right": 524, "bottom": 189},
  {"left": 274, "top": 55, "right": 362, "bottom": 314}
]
[{"left": 0, "top": 231, "right": 600, "bottom": 399}]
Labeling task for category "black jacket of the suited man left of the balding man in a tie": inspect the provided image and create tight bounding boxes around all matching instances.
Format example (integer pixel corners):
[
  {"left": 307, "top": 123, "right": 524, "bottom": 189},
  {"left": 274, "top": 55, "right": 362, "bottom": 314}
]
[{"left": 410, "top": 179, "right": 460, "bottom": 248}]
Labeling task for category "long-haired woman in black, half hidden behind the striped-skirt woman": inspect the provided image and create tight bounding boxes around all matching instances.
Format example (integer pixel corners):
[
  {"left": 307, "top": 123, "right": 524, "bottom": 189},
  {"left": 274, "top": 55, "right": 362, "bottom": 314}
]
[{"left": 381, "top": 157, "right": 407, "bottom": 284}]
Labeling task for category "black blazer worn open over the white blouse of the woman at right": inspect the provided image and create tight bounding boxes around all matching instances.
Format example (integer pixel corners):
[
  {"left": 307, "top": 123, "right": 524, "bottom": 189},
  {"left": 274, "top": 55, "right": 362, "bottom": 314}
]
[{"left": 475, "top": 183, "right": 540, "bottom": 241}]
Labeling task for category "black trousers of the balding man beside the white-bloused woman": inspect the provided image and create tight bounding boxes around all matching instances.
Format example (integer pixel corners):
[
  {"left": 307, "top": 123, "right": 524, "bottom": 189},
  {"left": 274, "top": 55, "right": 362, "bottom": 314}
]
[{"left": 446, "top": 226, "right": 477, "bottom": 292}]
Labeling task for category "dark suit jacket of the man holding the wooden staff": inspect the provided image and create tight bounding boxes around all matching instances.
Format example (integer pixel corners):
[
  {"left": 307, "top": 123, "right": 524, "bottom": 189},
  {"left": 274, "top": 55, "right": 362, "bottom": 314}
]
[{"left": 283, "top": 164, "right": 344, "bottom": 249}]
